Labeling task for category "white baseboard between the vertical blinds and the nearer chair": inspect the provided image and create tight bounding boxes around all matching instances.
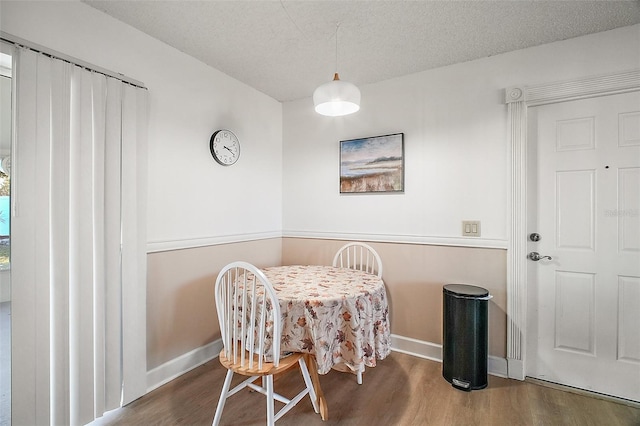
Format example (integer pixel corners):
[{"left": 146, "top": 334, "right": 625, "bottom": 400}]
[{"left": 147, "top": 339, "right": 222, "bottom": 393}]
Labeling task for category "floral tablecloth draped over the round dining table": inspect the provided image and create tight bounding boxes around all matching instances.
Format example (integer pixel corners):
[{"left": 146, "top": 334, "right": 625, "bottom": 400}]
[{"left": 263, "top": 265, "right": 391, "bottom": 374}]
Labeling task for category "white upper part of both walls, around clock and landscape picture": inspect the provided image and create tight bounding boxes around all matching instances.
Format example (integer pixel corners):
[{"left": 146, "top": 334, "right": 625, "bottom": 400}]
[{"left": 0, "top": 1, "right": 640, "bottom": 250}]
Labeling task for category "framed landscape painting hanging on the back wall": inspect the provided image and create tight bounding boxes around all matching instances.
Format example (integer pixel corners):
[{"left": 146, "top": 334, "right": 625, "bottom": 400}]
[{"left": 340, "top": 133, "right": 404, "bottom": 194}]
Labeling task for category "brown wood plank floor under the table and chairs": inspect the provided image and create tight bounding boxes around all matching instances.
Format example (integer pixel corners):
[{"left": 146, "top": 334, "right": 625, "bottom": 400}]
[{"left": 93, "top": 352, "right": 640, "bottom": 426}]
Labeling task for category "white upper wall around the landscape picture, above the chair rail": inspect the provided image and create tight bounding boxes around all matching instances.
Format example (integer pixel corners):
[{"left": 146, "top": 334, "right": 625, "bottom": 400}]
[{"left": 283, "top": 25, "right": 640, "bottom": 247}]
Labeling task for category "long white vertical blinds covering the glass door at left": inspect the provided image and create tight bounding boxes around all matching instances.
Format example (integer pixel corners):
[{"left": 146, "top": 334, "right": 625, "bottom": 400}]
[{"left": 11, "top": 48, "right": 147, "bottom": 425}]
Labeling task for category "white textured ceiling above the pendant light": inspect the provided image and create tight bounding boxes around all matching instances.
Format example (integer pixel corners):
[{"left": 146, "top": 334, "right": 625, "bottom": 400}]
[{"left": 82, "top": 0, "right": 640, "bottom": 101}]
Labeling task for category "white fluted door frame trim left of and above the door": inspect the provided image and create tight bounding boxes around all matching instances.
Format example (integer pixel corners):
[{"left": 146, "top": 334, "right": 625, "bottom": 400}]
[{"left": 505, "top": 69, "right": 640, "bottom": 380}]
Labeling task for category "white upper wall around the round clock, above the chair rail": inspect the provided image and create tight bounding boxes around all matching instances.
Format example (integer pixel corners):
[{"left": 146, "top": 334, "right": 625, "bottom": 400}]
[{"left": 0, "top": 1, "right": 282, "bottom": 250}]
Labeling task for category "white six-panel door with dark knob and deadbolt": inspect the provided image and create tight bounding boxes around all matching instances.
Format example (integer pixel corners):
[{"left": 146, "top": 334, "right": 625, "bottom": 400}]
[{"left": 527, "top": 92, "right": 640, "bottom": 401}]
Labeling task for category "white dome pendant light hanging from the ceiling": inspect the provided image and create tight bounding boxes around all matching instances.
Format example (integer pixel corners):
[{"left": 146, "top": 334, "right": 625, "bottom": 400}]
[{"left": 313, "top": 24, "right": 360, "bottom": 117}]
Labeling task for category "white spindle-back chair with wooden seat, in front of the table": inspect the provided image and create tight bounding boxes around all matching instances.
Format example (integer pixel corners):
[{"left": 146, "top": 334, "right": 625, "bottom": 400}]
[{"left": 213, "top": 262, "right": 319, "bottom": 426}]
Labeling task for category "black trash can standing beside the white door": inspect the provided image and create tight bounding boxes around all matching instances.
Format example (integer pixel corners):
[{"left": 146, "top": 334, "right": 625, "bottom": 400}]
[{"left": 442, "top": 284, "right": 491, "bottom": 391}]
